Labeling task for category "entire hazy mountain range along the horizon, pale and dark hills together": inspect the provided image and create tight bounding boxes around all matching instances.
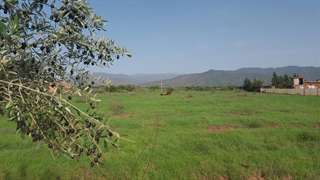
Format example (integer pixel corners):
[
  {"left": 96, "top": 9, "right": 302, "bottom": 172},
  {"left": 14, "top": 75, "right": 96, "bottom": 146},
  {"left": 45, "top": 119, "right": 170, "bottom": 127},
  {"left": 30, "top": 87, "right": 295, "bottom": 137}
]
[{"left": 95, "top": 66, "right": 320, "bottom": 87}]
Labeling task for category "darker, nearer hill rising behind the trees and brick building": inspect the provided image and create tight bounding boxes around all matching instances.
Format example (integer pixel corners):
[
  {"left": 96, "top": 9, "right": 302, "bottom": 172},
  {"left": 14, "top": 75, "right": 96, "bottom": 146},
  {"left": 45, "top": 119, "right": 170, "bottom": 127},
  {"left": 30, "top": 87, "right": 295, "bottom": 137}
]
[{"left": 145, "top": 66, "right": 320, "bottom": 87}]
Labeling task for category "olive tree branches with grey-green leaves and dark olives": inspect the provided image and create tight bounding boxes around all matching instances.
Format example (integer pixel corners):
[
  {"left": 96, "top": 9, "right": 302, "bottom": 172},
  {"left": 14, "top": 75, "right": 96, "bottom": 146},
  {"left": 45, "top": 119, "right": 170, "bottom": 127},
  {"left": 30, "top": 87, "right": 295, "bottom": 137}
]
[{"left": 0, "top": 0, "right": 130, "bottom": 165}]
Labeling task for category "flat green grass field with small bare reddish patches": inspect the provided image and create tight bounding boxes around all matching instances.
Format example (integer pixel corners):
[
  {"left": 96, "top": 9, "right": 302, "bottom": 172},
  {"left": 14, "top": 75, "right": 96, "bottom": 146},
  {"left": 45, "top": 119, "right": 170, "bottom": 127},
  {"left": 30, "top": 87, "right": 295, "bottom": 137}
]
[{"left": 0, "top": 90, "right": 320, "bottom": 180}]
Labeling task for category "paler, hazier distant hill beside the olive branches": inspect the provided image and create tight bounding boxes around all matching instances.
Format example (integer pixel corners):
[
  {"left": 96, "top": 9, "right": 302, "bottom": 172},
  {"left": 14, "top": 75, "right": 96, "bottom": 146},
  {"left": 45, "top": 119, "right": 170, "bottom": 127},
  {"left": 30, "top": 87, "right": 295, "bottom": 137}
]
[{"left": 92, "top": 72, "right": 178, "bottom": 85}]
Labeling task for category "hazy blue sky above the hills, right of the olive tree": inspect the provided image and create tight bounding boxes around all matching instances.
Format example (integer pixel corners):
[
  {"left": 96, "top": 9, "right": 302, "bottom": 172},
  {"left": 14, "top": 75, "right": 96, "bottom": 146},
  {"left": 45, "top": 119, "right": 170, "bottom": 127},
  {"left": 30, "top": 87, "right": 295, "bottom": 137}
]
[{"left": 89, "top": 0, "right": 320, "bottom": 74}]
